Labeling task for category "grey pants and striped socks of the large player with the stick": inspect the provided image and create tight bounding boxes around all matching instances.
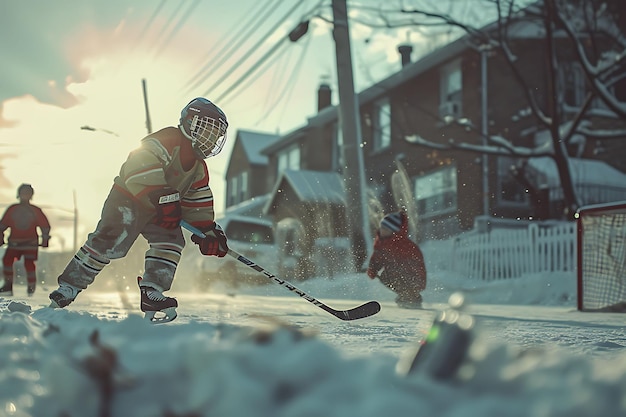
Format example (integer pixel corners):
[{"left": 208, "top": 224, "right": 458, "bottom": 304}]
[{"left": 58, "top": 186, "right": 185, "bottom": 291}]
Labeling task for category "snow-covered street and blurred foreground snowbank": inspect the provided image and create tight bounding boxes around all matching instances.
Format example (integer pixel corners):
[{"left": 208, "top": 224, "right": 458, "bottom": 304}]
[{"left": 0, "top": 237, "right": 626, "bottom": 417}]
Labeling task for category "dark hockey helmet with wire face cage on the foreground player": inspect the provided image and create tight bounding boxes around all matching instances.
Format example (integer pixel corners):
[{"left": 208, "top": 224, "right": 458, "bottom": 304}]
[{"left": 178, "top": 97, "right": 228, "bottom": 159}]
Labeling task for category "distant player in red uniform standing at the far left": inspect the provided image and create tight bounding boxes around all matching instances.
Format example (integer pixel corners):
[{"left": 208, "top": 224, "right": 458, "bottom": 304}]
[{"left": 0, "top": 184, "right": 50, "bottom": 296}]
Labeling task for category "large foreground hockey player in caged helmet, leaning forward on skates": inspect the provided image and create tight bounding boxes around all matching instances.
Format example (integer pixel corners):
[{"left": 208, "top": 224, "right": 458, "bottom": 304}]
[{"left": 50, "top": 98, "right": 228, "bottom": 322}]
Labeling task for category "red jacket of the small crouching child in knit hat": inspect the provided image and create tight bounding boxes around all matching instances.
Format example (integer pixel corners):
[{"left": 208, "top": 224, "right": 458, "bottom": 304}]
[{"left": 367, "top": 212, "right": 426, "bottom": 291}]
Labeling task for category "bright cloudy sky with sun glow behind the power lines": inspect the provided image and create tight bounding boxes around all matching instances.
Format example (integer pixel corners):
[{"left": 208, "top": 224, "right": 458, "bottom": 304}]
[{"left": 0, "top": 0, "right": 478, "bottom": 250}]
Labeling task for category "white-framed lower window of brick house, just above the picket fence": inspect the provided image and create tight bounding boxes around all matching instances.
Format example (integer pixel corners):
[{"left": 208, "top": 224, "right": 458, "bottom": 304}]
[{"left": 415, "top": 164, "right": 457, "bottom": 216}]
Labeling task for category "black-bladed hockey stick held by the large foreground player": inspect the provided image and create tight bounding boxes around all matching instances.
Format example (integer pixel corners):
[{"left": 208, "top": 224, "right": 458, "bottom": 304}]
[{"left": 180, "top": 220, "right": 380, "bottom": 321}]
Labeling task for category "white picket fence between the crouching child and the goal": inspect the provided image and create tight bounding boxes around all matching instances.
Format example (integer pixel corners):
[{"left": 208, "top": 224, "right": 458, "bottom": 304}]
[{"left": 452, "top": 222, "right": 577, "bottom": 280}]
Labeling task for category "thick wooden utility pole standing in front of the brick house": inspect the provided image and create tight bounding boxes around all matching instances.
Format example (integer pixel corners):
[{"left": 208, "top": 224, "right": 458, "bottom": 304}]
[{"left": 332, "top": 0, "right": 372, "bottom": 268}]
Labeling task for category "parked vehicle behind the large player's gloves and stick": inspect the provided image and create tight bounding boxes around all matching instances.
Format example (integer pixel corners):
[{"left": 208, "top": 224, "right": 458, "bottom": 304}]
[{"left": 193, "top": 215, "right": 295, "bottom": 288}]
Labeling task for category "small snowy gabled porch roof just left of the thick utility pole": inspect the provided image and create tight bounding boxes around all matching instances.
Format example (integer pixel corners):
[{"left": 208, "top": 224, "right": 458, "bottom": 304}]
[{"left": 263, "top": 170, "right": 345, "bottom": 213}]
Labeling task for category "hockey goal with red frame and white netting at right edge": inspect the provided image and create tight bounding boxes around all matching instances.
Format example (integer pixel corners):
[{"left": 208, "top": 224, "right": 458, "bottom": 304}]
[{"left": 577, "top": 201, "right": 626, "bottom": 312}]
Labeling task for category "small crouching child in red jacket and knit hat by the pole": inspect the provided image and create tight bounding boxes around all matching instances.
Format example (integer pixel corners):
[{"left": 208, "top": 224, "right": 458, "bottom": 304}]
[{"left": 367, "top": 210, "right": 426, "bottom": 308}]
